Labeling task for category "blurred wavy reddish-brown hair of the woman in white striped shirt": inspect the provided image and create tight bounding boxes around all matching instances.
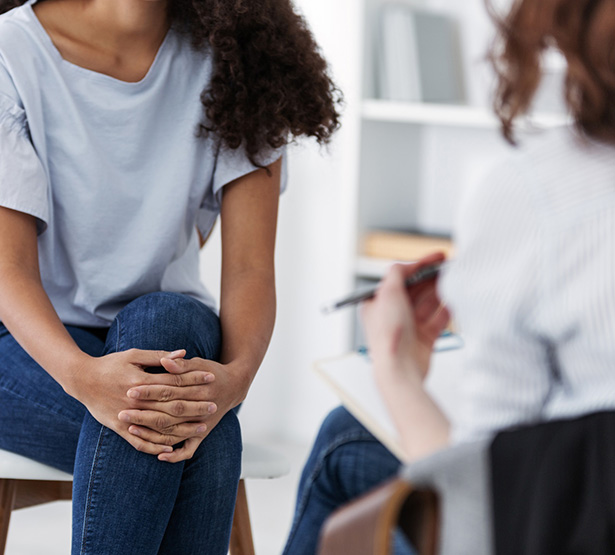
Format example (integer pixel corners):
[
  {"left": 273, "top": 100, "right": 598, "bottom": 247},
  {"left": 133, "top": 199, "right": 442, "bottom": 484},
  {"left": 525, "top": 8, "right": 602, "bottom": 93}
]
[{"left": 487, "top": 0, "right": 615, "bottom": 143}]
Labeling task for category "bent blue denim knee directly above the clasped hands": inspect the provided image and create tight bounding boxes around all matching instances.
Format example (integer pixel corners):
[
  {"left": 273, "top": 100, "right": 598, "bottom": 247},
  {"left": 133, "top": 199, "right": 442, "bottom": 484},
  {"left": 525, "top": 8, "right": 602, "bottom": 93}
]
[{"left": 109, "top": 292, "right": 221, "bottom": 360}]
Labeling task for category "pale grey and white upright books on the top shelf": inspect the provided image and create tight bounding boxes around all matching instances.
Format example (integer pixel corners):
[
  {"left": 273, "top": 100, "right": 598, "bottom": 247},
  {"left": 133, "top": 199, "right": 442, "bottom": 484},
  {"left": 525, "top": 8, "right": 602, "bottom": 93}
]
[{"left": 378, "top": 1, "right": 465, "bottom": 104}]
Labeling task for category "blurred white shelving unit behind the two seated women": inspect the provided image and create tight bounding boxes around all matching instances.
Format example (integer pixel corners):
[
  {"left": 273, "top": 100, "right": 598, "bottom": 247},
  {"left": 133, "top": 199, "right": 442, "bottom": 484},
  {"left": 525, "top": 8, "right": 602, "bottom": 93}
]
[{"left": 354, "top": 0, "right": 567, "bottom": 282}]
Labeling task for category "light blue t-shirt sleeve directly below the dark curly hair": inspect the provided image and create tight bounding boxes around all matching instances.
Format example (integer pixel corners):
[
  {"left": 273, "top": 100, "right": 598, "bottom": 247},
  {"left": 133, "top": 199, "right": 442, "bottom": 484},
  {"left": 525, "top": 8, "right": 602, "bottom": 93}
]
[{"left": 197, "top": 143, "right": 288, "bottom": 237}]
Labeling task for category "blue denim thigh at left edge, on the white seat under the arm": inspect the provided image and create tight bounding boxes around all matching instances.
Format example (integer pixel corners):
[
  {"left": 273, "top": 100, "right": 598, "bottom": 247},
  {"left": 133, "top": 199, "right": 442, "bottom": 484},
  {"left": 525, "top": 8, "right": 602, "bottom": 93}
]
[{"left": 0, "top": 324, "right": 104, "bottom": 473}]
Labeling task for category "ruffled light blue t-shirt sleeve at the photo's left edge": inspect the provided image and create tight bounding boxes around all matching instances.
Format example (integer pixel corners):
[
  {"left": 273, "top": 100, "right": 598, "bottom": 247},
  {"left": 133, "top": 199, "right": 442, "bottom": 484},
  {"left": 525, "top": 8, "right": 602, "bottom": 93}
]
[{"left": 0, "top": 88, "right": 49, "bottom": 235}]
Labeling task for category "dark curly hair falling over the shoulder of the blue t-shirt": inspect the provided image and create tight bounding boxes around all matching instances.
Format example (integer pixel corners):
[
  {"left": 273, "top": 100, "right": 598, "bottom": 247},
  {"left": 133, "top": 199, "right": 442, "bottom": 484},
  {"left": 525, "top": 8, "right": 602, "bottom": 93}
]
[{"left": 0, "top": 0, "right": 342, "bottom": 167}]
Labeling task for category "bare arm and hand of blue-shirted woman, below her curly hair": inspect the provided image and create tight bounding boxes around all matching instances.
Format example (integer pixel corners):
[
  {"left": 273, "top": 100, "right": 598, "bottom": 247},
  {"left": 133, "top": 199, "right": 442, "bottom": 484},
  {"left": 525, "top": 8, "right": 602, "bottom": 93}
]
[{"left": 122, "top": 160, "right": 282, "bottom": 462}]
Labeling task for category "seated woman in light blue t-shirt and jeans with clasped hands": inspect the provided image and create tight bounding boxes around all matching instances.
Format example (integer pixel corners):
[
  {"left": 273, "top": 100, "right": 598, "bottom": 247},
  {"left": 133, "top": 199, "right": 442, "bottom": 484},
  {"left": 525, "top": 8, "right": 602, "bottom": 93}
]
[{"left": 0, "top": 0, "right": 339, "bottom": 555}]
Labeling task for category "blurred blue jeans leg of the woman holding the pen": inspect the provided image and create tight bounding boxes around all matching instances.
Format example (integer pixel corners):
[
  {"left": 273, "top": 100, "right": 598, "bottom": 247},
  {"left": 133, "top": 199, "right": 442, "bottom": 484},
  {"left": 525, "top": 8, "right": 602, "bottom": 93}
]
[{"left": 284, "top": 407, "right": 414, "bottom": 555}]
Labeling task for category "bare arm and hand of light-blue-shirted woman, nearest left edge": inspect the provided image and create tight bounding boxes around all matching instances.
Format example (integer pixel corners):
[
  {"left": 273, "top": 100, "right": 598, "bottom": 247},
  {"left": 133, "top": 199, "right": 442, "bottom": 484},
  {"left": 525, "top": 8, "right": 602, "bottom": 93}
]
[{"left": 0, "top": 207, "right": 205, "bottom": 455}]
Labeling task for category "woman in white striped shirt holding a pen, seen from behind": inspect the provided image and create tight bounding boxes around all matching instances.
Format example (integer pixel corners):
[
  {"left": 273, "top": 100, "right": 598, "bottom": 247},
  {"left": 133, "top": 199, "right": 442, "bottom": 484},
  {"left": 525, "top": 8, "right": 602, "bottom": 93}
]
[{"left": 285, "top": 0, "right": 615, "bottom": 555}]
